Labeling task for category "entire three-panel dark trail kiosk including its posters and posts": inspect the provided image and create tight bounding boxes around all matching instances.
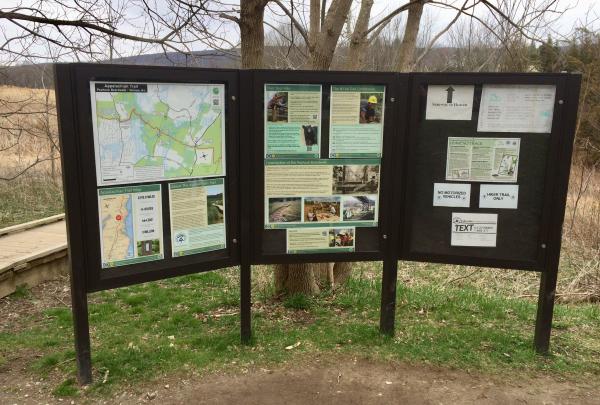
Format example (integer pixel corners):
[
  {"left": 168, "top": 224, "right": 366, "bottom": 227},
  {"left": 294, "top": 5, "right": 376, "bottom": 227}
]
[{"left": 55, "top": 64, "right": 580, "bottom": 382}]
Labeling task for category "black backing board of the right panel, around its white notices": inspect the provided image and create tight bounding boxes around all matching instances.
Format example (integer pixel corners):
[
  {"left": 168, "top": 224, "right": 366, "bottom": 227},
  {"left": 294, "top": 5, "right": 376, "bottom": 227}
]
[{"left": 397, "top": 74, "right": 577, "bottom": 271}]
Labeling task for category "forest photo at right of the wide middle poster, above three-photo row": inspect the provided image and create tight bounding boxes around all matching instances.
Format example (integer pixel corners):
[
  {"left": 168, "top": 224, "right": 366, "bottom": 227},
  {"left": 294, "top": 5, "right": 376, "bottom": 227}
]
[{"left": 333, "top": 165, "right": 379, "bottom": 194}]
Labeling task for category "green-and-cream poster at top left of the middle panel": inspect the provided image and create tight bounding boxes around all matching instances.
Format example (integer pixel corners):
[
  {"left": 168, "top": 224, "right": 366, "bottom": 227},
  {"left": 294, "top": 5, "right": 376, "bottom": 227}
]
[{"left": 264, "top": 84, "right": 321, "bottom": 159}]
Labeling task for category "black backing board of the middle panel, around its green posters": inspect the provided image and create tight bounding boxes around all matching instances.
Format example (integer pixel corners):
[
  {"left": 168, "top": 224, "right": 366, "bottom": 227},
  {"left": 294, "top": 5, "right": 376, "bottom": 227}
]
[{"left": 242, "top": 70, "right": 408, "bottom": 264}]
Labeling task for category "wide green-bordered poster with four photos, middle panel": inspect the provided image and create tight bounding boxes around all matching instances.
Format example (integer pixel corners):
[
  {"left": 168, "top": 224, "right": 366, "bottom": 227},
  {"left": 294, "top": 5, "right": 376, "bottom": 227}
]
[{"left": 265, "top": 159, "right": 380, "bottom": 229}]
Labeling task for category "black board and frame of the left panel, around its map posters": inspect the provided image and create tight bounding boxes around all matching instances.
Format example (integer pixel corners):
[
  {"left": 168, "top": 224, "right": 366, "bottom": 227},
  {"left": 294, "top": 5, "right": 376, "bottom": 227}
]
[{"left": 55, "top": 64, "right": 240, "bottom": 291}]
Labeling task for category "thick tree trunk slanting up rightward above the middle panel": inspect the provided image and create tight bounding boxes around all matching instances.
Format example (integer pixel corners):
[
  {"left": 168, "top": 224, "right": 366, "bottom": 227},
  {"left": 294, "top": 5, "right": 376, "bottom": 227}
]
[{"left": 311, "top": 0, "right": 352, "bottom": 70}]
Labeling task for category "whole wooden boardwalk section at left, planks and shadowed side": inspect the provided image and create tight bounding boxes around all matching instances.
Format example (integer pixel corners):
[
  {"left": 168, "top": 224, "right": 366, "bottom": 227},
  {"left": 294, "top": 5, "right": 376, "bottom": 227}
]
[{"left": 0, "top": 214, "right": 67, "bottom": 297}]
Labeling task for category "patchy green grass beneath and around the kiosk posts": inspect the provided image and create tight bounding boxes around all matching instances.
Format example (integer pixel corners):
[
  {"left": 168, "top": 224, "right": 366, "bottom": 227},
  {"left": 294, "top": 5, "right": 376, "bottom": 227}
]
[{"left": 0, "top": 263, "right": 600, "bottom": 396}]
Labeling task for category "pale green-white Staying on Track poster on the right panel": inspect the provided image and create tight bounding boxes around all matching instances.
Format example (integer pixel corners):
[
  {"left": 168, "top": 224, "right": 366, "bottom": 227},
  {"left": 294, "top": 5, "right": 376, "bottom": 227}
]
[{"left": 446, "top": 137, "right": 521, "bottom": 183}]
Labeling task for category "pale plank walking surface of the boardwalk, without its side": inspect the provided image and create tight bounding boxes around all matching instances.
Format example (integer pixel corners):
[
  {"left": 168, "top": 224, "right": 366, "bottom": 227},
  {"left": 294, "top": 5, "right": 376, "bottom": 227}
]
[{"left": 0, "top": 221, "right": 67, "bottom": 269}]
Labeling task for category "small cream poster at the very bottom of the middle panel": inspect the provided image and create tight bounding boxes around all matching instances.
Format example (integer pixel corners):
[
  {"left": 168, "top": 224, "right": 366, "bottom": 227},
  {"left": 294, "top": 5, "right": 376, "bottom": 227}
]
[{"left": 286, "top": 227, "right": 356, "bottom": 254}]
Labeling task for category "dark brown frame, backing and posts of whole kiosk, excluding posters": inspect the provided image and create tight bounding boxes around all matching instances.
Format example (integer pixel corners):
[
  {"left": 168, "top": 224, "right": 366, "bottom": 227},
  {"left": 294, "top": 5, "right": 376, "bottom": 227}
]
[{"left": 55, "top": 64, "right": 580, "bottom": 384}]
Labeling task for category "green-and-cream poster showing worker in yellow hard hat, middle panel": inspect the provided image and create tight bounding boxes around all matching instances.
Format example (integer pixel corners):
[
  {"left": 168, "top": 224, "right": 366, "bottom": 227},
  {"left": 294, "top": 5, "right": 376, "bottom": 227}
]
[{"left": 329, "top": 85, "right": 385, "bottom": 158}]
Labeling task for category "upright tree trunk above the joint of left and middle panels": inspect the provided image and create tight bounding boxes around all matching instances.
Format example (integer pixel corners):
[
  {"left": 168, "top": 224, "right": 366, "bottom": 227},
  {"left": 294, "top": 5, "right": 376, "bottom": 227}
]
[{"left": 239, "top": 0, "right": 267, "bottom": 69}]
